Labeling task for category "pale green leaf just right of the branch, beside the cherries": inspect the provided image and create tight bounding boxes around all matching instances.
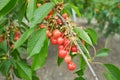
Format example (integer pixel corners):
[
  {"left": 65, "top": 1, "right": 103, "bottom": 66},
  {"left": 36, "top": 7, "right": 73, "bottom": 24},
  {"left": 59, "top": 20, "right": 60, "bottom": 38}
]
[{"left": 73, "top": 27, "right": 93, "bottom": 45}]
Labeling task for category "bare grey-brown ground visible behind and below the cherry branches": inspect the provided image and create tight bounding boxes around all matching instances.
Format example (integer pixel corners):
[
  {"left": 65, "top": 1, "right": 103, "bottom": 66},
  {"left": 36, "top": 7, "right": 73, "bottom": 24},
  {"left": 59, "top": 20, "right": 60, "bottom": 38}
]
[{"left": 0, "top": 18, "right": 120, "bottom": 80}]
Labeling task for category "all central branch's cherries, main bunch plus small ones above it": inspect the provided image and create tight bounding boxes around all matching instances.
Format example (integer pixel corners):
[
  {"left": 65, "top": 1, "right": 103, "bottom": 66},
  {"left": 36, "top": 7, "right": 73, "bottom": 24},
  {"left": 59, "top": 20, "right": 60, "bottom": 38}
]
[{"left": 39, "top": 10, "right": 78, "bottom": 71}]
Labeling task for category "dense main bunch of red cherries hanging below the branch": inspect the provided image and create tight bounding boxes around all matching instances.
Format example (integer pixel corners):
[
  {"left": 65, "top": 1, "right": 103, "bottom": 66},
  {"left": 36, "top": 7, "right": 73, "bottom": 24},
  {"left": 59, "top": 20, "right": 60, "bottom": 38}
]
[{"left": 46, "top": 29, "right": 78, "bottom": 70}]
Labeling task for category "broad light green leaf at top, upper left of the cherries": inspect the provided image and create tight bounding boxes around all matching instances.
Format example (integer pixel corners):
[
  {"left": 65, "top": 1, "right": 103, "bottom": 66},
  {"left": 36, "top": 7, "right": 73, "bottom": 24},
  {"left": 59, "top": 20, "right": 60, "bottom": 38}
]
[{"left": 31, "top": 3, "right": 54, "bottom": 27}]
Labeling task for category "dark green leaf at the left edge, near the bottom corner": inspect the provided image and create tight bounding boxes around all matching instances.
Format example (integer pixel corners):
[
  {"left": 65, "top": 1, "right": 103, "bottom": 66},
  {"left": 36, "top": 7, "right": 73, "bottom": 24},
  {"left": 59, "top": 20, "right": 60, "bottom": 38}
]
[{"left": 0, "top": 60, "right": 11, "bottom": 76}]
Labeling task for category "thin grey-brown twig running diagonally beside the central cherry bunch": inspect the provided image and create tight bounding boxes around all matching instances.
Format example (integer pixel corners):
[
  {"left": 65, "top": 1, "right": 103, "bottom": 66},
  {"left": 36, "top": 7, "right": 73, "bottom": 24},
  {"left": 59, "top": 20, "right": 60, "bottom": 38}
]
[{"left": 57, "top": 13, "right": 98, "bottom": 80}]
